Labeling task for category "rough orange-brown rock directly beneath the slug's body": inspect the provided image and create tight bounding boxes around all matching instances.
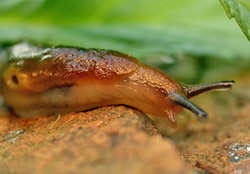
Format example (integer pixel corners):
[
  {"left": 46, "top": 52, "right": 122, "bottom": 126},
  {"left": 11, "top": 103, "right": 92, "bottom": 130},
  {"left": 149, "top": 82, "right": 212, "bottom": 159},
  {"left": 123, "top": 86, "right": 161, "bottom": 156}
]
[{"left": 0, "top": 106, "right": 187, "bottom": 174}]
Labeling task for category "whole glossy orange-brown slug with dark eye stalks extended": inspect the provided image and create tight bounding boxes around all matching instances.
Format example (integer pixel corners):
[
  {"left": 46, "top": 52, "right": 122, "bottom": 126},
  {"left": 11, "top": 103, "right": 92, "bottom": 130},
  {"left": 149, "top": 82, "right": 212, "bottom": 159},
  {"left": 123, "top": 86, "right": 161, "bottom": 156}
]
[{"left": 0, "top": 42, "right": 234, "bottom": 128}]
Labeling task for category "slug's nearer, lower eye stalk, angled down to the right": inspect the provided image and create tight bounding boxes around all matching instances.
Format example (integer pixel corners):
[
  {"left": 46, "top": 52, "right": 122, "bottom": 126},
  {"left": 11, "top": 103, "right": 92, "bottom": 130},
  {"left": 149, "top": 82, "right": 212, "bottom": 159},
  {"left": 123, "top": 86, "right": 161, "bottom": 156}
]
[{"left": 168, "top": 92, "right": 207, "bottom": 121}]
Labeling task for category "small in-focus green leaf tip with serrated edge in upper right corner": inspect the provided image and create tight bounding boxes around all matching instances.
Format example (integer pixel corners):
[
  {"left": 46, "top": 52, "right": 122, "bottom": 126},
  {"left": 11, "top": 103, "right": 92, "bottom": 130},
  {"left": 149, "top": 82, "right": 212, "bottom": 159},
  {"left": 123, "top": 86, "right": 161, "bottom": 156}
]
[{"left": 220, "top": 0, "right": 250, "bottom": 41}]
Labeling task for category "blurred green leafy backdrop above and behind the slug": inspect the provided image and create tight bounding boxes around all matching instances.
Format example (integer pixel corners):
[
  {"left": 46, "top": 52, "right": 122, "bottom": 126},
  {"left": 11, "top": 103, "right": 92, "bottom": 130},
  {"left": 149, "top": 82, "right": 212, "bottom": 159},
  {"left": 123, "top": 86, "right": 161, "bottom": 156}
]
[{"left": 0, "top": 0, "right": 250, "bottom": 84}]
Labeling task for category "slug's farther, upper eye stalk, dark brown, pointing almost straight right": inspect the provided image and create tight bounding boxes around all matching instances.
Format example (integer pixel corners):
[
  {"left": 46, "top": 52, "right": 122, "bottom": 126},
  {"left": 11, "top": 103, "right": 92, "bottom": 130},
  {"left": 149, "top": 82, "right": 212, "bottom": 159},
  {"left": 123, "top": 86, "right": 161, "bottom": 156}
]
[{"left": 184, "top": 80, "right": 235, "bottom": 98}]
